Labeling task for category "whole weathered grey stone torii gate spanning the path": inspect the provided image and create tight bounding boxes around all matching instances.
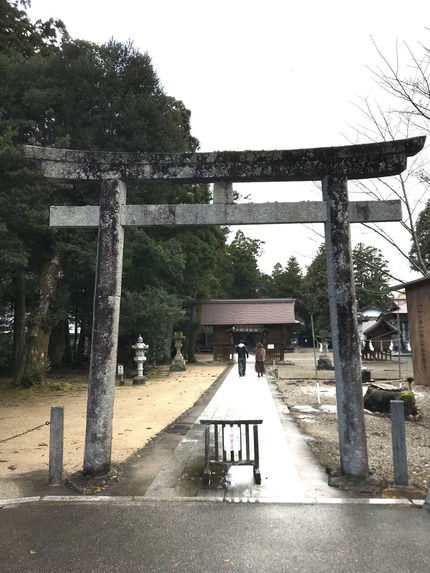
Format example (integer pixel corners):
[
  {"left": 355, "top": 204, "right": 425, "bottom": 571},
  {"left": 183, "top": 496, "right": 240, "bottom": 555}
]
[{"left": 26, "top": 137, "right": 425, "bottom": 478}]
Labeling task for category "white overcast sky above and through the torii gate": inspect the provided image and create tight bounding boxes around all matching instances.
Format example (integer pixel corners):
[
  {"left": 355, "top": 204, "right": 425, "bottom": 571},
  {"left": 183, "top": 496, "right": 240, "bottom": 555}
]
[{"left": 29, "top": 0, "right": 430, "bottom": 281}]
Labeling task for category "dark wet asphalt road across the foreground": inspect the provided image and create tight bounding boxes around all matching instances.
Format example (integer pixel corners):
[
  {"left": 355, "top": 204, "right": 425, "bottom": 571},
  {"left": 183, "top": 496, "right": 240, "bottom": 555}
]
[{"left": 0, "top": 498, "right": 430, "bottom": 573}]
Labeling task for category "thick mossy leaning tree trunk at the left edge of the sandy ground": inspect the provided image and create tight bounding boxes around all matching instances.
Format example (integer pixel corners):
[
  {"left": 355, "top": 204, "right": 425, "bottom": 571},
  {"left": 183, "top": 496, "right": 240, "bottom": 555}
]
[{"left": 14, "top": 255, "right": 61, "bottom": 388}]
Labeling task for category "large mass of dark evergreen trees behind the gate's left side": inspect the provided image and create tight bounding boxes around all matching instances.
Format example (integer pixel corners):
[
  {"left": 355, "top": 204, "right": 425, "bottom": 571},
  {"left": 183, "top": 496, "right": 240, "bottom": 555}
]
[{"left": 0, "top": 1, "right": 232, "bottom": 385}]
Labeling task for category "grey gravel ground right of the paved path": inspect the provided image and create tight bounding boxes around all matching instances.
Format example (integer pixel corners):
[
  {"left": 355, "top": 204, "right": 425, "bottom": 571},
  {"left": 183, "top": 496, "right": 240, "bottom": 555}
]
[{"left": 277, "top": 350, "right": 430, "bottom": 499}]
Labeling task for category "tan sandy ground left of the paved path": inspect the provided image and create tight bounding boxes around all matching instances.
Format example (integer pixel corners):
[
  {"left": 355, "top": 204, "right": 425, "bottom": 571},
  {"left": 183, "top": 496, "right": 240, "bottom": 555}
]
[{"left": 0, "top": 363, "right": 226, "bottom": 476}]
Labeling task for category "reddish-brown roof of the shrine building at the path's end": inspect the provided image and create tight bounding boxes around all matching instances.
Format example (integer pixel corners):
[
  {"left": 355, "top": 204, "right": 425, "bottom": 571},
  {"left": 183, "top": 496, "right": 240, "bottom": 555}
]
[{"left": 201, "top": 298, "right": 296, "bottom": 326}]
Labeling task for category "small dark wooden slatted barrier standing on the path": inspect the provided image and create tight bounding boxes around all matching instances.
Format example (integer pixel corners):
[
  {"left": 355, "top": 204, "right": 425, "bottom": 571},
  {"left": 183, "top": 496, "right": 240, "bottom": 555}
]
[{"left": 200, "top": 420, "right": 263, "bottom": 485}]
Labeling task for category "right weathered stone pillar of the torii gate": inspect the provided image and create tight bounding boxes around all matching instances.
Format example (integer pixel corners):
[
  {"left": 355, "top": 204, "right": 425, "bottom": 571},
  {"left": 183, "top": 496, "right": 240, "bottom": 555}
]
[{"left": 322, "top": 175, "right": 369, "bottom": 477}]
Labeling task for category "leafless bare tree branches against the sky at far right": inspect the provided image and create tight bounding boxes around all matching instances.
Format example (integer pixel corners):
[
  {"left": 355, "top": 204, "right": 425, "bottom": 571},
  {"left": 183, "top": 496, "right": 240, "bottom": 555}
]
[{"left": 354, "top": 34, "right": 430, "bottom": 276}]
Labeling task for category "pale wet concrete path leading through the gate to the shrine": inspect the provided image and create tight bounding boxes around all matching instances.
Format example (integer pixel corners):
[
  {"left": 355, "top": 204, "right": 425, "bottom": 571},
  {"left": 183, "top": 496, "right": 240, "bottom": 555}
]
[{"left": 145, "top": 358, "right": 345, "bottom": 502}]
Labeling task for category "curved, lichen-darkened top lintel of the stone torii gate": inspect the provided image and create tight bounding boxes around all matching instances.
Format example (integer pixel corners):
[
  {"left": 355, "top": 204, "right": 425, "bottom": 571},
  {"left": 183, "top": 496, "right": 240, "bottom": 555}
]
[{"left": 25, "top": 136, "right": 425, "bottom": 183}]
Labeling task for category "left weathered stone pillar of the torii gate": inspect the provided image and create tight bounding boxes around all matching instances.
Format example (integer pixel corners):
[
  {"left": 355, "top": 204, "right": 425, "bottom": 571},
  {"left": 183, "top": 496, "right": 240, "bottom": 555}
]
[{"left": 83, "top": 179, "right": 126, "bottom": 475}]
